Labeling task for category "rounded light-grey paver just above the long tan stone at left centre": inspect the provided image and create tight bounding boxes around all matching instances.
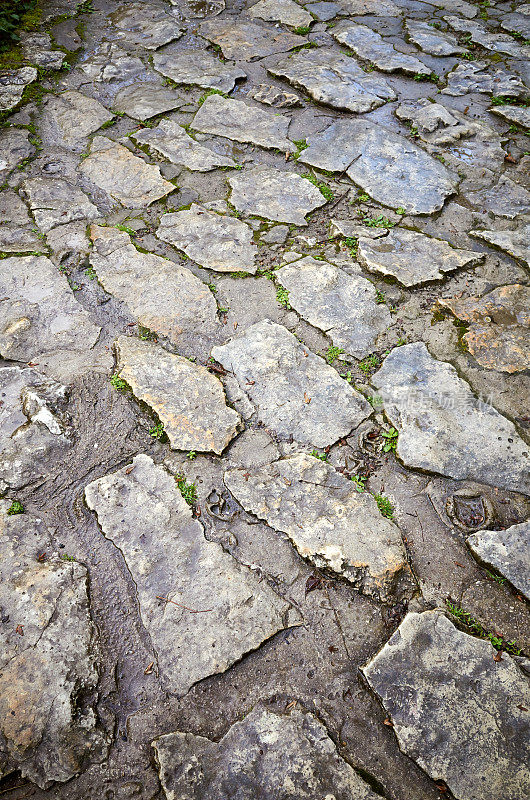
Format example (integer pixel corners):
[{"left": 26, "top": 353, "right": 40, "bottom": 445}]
[{"left": 156, "top": 203, "right": 257, "bottom": 273}]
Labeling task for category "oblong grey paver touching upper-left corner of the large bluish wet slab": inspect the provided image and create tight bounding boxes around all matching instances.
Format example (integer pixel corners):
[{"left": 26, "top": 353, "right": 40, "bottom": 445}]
[{"left": 191, "top": 94, "right": 295, "bottom": 153}]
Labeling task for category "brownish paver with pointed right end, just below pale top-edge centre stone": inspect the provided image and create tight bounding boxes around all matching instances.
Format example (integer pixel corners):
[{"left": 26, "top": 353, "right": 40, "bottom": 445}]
[{"left": 199, "top": 17, "right": 307, "bottom": 61}]
